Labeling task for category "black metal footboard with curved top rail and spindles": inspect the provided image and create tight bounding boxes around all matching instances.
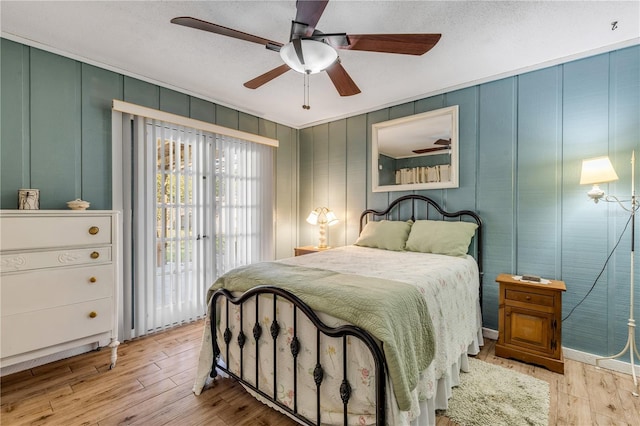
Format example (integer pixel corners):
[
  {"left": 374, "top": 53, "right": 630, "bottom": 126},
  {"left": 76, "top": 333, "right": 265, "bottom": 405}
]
[{"left": 210, "top": 286, "right": 386, "bottom": 426}]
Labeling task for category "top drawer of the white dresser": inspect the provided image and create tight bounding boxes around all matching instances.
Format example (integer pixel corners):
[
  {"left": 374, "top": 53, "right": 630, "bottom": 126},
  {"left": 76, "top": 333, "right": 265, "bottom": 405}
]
[{"left": 0, "top": 214, "right": 111, "bottom": 251}]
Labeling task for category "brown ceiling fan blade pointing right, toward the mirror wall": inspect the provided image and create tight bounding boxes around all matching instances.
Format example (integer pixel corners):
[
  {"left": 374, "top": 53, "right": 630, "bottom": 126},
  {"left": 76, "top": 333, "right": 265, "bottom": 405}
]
[{"left": 334, "top": 34, "right": 441, "bottom": 56}]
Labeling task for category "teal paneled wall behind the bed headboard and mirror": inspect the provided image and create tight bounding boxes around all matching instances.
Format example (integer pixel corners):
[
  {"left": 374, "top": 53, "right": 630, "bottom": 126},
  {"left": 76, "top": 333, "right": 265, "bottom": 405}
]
[{"left": 299, "top": 46, "right": 640, "bottom": 354}]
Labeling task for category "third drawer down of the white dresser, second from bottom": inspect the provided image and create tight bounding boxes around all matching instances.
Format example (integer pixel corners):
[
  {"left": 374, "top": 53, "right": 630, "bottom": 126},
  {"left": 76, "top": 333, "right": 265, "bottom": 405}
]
[{"left": 0, "top": 264, "right": 115, "bottom": 317}]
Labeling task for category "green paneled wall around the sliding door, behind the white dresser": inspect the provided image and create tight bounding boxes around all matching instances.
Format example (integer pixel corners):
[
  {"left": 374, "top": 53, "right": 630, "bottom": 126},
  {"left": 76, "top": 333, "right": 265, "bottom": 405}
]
[{"left": 0, "top": 39, "right": 298, "bottom": 257}]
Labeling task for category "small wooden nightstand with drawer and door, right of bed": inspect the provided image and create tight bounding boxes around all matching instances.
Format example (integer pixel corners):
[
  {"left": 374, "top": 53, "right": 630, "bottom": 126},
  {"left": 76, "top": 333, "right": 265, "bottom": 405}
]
[{"left": 496, "top": 274, "right": 567, "bottom": 374}]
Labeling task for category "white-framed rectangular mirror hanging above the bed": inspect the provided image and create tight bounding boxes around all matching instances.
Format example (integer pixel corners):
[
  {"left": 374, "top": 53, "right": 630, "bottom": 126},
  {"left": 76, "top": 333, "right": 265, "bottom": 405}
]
[{"left": 371, "top": 105, "right": 459, "bottom": 192}]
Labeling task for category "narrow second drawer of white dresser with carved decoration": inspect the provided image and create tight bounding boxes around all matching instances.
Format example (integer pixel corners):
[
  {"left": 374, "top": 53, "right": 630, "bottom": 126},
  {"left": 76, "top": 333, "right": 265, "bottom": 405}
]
[{"left": 0, "top": 247, "right": 111, "bottom": 274}]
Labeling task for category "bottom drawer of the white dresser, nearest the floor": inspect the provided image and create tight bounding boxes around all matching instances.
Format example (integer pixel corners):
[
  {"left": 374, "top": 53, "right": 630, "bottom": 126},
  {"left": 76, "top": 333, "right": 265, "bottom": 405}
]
[{"left": 1, "top": 298, "right": 113, "bottom": 358}]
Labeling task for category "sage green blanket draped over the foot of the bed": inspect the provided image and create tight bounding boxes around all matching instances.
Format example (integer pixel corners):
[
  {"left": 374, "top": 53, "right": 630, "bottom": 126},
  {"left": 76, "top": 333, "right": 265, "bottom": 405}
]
[{"left": 208, "top": 262, "right": 435, "bottom": 411}]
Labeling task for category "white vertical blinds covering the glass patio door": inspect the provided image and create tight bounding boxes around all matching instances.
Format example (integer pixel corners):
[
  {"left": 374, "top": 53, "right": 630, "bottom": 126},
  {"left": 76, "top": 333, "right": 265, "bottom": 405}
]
[{"left": 123, "top": 117, "right": 274, "bottom": 339}]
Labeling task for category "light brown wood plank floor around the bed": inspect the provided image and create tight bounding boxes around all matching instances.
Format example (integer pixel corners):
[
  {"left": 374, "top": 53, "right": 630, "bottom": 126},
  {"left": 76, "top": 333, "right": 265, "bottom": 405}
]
[{"left": 0, "top": 322, "right": 640, "bottom": 426}]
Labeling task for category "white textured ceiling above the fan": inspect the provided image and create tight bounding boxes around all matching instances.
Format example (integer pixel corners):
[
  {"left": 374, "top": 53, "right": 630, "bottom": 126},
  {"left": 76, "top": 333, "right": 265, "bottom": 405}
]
[{"left": 0, "top": 0, "right": 640, "bottom": 128}]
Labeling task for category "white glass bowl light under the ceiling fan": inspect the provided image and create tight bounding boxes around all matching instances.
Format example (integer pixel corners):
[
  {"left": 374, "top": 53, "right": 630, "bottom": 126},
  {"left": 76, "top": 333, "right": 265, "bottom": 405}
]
[{"left": 280, "top": 40, "right": 338, "bottom": 74}]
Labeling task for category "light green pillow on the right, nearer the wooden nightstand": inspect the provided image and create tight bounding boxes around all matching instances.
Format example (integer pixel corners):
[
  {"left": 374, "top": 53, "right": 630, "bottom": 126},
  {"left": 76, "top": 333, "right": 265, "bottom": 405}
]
[{"left": 406, "top": 220, "right": 478, "bottom": 257}]
